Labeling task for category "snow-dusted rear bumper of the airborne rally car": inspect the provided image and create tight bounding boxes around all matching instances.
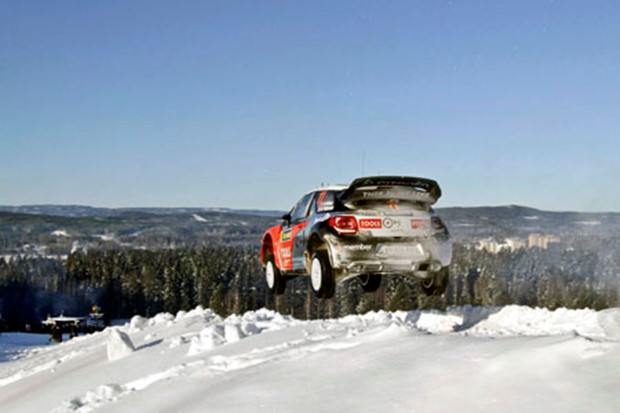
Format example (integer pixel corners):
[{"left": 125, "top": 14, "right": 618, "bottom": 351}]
[{"left": 325, "top": 235, "right": 452, "bottom": 281}]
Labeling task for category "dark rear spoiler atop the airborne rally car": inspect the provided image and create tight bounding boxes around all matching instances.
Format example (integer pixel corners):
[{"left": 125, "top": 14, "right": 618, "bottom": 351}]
[{"left": 340, "top": 176, "right": 441, "bottom": 205}]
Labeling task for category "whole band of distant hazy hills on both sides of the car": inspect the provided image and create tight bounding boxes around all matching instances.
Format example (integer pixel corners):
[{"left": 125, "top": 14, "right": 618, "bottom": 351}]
[{"left": 0, "top": 205, "right": 620, "bottom": 255}]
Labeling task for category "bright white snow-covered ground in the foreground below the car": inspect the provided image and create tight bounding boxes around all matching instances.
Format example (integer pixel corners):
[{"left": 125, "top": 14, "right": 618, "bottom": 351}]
[{"left": 0, "top": 306, "right": 620, "bottom": 413}]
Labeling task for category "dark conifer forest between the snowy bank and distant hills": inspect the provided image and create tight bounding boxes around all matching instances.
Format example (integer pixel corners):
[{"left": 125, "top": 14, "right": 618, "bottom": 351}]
[{"left": 0, "top": 240, "right": 620, "bottom": 329}]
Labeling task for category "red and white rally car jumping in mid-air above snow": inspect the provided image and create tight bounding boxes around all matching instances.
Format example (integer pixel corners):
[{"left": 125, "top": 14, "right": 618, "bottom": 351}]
[{"left": 261, "top": 176, "right": 452, "bottom": 298}]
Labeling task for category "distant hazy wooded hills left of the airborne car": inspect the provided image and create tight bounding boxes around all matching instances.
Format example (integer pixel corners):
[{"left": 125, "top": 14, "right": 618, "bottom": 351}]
[{"left": 0, "top": 208, "right": 277, "bottom": 255}]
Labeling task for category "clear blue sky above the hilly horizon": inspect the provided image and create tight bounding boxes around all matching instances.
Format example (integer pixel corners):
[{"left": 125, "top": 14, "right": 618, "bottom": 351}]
[{"left": 0, "top": 0, "right": 620, "bottom": 211}]
